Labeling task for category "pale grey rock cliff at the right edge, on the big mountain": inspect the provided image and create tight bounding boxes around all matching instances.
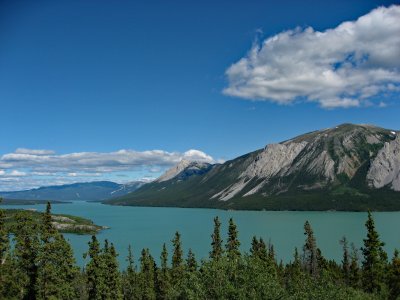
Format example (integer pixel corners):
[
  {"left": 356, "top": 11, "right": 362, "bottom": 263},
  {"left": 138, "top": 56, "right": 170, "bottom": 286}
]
[{"left": 367, "top": 132, "right": 400, "bottom": 191}]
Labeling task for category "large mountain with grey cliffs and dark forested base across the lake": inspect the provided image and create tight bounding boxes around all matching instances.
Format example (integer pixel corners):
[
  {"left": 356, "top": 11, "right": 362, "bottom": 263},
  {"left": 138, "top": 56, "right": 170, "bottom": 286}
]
[{"left": 106, "top": 124, "right": 400, "bottom": 210}]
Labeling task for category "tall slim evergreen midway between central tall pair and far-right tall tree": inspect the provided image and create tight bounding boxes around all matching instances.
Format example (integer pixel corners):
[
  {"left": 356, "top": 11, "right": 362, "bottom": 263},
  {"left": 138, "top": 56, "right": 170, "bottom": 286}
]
[{"left": 303, "top": 221, "right": 320, "bottom": 277}]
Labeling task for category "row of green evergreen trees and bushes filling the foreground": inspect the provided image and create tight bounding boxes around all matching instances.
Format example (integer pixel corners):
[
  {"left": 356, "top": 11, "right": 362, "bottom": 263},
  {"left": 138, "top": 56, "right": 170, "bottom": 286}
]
[{"left": 0, "top": 200, "right": 400, "bottom": 300}]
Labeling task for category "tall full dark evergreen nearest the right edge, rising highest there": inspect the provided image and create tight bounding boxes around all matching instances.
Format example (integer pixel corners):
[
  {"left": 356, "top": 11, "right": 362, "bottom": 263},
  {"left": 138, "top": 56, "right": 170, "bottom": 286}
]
[{"left": 362, "top": 211, "right": 387, "bottom": 293}]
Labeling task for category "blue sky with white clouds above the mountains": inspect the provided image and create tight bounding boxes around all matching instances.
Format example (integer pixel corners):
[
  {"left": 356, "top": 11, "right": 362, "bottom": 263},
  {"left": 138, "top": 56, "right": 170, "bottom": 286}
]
[{"left": 0, "top": 0, "right": 400, "bottom": 191}]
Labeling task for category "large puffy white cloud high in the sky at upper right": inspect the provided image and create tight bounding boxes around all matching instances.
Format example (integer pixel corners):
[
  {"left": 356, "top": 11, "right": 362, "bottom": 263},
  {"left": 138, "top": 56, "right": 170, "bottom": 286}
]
[{"left": 223, "top": 5, "right": 400, "bottom": 108}]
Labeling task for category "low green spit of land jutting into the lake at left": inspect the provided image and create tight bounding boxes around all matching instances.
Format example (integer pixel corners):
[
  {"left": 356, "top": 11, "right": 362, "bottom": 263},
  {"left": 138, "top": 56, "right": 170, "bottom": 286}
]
[{"left": 4, "top": 209, "right": 108, "bottom": 234}]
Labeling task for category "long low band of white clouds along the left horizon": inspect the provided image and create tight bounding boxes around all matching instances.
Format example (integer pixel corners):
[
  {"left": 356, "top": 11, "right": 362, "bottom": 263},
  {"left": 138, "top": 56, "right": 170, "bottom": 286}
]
[{"left": 0, "top": 148, "right": 215, "bottom": 190}]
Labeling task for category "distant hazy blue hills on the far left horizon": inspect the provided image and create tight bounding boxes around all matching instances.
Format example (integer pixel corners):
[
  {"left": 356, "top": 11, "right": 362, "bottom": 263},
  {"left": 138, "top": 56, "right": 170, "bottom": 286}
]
[{"left": 0, "top": 181, "right": 145, "bottom": 201}]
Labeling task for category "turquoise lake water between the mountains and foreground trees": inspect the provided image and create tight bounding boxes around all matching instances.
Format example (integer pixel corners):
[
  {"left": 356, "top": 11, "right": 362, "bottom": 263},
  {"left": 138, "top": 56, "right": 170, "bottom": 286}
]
[{"left": 2, "top": 201, "right": 400, "bottom": 267}]
